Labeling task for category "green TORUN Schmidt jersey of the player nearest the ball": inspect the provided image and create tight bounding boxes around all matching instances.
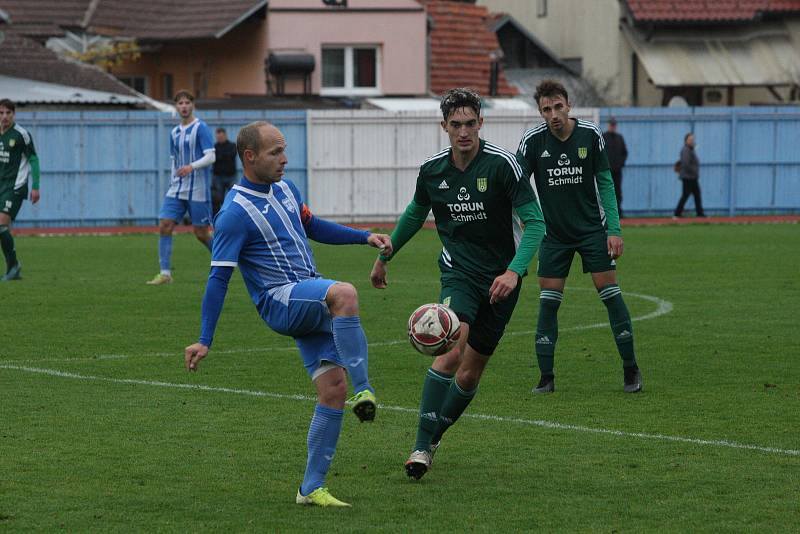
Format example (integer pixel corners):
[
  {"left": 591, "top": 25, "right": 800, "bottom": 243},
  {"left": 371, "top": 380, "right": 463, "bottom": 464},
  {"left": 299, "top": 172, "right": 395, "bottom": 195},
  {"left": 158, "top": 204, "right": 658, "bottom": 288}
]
[{"left": 414, "top": 139, "right": 537, "bottom": 282}]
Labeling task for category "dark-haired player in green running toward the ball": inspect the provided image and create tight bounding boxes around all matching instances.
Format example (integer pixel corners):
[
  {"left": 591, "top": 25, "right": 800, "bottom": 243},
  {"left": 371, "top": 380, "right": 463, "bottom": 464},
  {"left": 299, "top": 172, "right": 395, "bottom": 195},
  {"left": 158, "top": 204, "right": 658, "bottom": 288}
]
[{"left": 370, "top": 89, "right": 544, "bottom": 479}]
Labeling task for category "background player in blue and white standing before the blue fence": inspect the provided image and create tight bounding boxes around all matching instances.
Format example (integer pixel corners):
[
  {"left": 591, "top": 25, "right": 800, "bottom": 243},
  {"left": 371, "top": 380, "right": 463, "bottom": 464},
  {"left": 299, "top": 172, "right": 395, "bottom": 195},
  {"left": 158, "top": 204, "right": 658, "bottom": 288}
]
[{"left": 147, "top": 90, "right": 216, "bottom": 286}]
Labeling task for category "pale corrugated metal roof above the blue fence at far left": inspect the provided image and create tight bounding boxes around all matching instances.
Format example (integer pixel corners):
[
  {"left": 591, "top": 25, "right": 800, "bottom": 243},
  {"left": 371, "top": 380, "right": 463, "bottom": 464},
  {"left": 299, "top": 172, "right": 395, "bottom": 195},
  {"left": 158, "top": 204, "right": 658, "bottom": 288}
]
[{"left": 0, "top": 75, "right": 146, "bottom": 106}]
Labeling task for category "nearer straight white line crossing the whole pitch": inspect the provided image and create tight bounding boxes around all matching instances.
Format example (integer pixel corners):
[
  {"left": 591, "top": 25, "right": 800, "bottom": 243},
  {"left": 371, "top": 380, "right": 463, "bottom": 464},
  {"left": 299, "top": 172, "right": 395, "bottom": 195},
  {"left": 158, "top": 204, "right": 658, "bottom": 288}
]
[{"left": 0, "top": 364, "right": 800, "bottom": 456}]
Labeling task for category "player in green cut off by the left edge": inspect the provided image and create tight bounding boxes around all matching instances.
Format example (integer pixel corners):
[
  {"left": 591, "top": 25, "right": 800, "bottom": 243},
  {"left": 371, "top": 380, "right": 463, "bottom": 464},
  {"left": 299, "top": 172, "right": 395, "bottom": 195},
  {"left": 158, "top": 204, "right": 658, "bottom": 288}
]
[{"left": 0, "top": 98, "right": 39, "bottom": 282}]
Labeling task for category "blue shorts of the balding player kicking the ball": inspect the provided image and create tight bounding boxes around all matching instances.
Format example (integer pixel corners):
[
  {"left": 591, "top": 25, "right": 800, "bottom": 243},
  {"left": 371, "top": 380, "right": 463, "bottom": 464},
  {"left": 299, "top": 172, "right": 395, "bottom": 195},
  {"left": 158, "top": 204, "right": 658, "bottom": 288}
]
[{"left": 261, "top": 278, "right": 345, "bottom": 380}]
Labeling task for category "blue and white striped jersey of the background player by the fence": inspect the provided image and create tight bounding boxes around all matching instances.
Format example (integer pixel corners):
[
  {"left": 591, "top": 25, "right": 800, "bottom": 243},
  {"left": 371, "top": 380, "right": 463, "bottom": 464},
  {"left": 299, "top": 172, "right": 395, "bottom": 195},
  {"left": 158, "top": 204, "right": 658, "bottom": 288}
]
[{"left": 167, "top": 119, "right": 214, "bottom": 202}]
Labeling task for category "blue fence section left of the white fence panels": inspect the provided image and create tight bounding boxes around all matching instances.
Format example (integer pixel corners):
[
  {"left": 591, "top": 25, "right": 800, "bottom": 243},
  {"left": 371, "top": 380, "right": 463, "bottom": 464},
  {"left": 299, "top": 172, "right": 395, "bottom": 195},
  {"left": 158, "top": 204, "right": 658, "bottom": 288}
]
[{"left": 15, "top": 110, "right": 307, "bottom": 227}]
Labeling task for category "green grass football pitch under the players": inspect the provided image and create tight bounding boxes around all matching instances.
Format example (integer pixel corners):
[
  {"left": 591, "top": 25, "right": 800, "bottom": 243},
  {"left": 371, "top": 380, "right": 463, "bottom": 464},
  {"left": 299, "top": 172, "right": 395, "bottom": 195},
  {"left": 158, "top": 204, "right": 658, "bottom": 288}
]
[{"left": 0, "top": 225, "right": 800, "bottom": 532}]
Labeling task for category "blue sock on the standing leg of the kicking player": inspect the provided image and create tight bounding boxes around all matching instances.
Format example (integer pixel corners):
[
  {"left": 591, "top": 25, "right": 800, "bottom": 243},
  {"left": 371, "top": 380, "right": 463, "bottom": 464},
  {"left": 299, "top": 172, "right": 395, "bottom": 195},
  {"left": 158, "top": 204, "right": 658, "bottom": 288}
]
[{"left": 300, "top": 404, "right": 344, "bottom": 495}]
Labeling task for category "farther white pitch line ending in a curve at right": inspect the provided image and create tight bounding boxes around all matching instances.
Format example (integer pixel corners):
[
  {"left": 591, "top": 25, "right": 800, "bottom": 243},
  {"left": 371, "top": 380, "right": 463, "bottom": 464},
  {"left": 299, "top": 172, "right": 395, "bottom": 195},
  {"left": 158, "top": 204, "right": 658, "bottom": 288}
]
[{"left": 0, "top": 287, "right": 673, "bottom": 364}]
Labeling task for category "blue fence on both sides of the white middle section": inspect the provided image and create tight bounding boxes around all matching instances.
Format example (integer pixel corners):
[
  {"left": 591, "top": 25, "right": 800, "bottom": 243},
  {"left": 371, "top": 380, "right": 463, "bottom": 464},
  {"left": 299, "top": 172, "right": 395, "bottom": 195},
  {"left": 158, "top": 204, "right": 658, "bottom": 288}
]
[{"left": 16, "top": 107, "right": 800, "bottom": 227}]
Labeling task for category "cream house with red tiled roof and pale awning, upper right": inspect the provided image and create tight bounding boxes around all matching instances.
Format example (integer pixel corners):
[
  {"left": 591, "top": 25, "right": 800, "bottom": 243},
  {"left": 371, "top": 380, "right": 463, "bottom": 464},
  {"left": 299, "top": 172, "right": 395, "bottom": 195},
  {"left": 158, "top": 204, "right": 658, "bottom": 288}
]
[{"left": 478, "top": 0, "right": 800, "bottom": 106}]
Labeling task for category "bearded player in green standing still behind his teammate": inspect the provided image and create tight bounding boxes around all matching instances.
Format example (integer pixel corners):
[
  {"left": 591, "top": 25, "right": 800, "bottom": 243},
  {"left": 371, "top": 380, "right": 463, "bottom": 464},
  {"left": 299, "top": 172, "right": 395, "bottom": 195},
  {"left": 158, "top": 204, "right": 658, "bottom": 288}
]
[{"left": 517, "top": 80, "right": 642, "bottom": 393}]
